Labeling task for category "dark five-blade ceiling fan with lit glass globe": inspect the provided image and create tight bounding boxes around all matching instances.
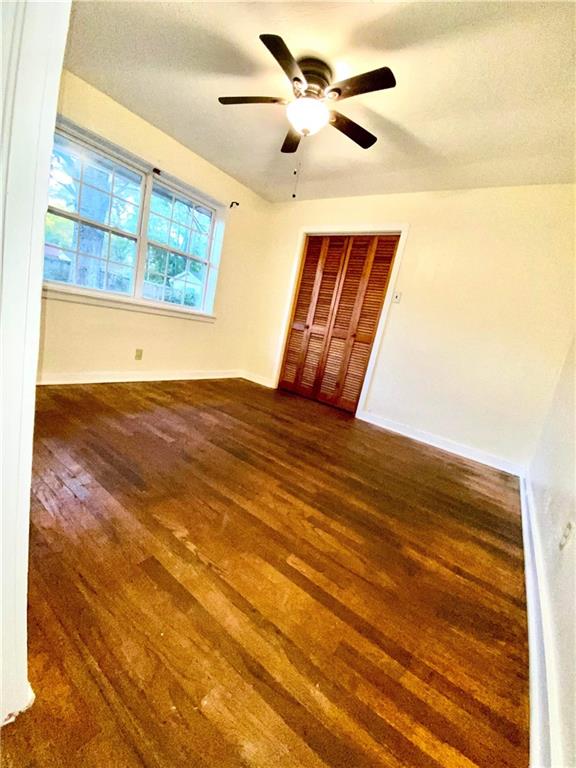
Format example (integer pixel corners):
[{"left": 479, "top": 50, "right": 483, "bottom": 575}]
[{"left": 218, "top": 35, "right": 396, "bottom": 152}]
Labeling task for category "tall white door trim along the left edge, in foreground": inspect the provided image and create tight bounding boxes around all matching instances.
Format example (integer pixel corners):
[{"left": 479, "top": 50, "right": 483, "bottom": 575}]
[{"left": 0, "top": 2, "right": 70, "bottom": 723}]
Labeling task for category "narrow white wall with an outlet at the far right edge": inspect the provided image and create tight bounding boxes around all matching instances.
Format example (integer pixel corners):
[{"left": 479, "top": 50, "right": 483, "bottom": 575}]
[{"left": 528, "top": 343, "right": 576, "bottom": 768}]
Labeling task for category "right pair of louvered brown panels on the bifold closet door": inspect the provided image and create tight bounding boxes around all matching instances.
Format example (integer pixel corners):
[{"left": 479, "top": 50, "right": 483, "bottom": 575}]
[{"left": 317, "top": 235, "right": 399, "bottom": 412}]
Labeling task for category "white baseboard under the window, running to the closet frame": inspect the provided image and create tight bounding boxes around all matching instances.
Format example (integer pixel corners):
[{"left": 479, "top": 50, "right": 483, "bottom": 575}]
[{"left": 36, "top": 369, "right": 276, "bottom": 389}]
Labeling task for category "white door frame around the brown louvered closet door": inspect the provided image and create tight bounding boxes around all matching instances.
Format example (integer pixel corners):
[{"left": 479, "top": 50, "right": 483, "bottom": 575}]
[{"left": 273, "top": 223, "right": 409, "bottom": 418}]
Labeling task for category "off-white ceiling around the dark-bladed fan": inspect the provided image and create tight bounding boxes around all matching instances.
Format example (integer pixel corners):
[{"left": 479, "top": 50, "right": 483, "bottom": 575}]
[{"left": 65, "top": 2, "right": 576, "bottom": 200}]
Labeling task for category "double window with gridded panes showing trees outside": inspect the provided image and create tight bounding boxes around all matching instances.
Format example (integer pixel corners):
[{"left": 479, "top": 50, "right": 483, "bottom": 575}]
[{"left": 44, "top": 133, "right": 217, "bottom": 313}]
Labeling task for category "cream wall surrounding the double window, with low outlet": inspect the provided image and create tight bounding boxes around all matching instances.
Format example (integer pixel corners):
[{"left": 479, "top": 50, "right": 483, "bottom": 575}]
[{"left": 39, "top": 72, "right": 269, "bottom": 383}]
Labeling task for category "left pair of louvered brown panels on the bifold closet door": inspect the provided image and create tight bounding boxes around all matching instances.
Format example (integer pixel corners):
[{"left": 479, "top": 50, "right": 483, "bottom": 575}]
[{"left": 280, "top": 236, "right": 348, "bottom": 397}]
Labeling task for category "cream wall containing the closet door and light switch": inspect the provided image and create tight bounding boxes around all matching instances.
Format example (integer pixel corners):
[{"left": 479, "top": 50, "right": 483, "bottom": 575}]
[{"left": 245, "top": 185, "right": 574, "bottom": 469}]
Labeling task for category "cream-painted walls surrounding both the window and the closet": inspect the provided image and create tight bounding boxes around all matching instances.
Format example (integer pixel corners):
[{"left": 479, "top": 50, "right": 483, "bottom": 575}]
[{"left": 39, "top": 73, "right": 574, "bottom": 468}]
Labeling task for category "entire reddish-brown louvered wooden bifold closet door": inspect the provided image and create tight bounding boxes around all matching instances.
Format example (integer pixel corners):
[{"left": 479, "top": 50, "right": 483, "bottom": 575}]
[{"left": 279, "top": 234, "right": 400, "bottom": 412}]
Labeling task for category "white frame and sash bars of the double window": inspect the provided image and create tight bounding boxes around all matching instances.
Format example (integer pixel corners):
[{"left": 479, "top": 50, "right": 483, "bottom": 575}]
[{"left": 43, "top": 117, "right": 226, "bottom": 321}]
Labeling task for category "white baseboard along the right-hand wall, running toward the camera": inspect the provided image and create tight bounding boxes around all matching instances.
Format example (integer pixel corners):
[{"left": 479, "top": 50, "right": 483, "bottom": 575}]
[{"left": 520, "top": 477, "right": 552, "bottom": 768}]
